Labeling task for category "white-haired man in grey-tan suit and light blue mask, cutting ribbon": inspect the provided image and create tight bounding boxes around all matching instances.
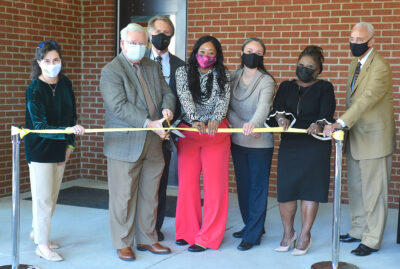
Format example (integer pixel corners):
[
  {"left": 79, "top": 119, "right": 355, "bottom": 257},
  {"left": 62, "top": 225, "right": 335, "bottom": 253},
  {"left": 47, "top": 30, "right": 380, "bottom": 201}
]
[{"left": 100, "top": 23, "right": 176, "bottom": 261}]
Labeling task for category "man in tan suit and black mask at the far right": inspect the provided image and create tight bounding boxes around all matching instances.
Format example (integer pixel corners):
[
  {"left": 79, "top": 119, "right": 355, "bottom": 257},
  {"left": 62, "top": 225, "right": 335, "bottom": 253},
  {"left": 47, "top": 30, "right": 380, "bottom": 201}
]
[{"left": 324, "top": 22, "right": 395, "bottom": 256}]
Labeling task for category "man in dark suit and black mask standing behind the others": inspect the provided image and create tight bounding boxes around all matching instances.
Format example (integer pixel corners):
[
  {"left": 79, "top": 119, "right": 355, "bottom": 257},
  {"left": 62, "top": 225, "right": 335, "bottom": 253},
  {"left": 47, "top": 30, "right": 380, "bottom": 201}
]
[{"left": 145, "top": 15, "right": 185, "bottom": 241}]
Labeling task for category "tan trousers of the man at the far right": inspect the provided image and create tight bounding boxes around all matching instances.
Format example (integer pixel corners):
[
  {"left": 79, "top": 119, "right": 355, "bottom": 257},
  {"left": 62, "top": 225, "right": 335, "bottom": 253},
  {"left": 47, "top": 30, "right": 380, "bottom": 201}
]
[{"left": 346, "top": 147, "right": 392, "bottom": 249}]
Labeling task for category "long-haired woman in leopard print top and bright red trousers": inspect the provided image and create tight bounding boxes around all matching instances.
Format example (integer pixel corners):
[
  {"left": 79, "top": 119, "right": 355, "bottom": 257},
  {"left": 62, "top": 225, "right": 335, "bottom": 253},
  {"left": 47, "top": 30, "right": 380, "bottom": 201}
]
[{"left": 175, "top": 36, "right": 230, "bottom": 252}]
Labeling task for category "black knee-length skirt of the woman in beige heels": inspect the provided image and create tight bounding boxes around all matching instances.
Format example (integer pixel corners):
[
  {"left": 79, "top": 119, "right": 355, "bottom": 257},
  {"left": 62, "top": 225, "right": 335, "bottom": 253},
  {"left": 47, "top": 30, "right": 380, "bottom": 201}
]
[{"left": 278, "top": 133, "right": 332, "bottom": 203}]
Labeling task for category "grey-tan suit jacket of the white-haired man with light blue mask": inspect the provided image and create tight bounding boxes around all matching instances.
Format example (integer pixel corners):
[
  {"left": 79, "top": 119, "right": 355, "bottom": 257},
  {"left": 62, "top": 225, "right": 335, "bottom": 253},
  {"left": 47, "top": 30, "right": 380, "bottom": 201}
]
[{"left": 100, "top": 52, "right": 176, "bottom": 162}]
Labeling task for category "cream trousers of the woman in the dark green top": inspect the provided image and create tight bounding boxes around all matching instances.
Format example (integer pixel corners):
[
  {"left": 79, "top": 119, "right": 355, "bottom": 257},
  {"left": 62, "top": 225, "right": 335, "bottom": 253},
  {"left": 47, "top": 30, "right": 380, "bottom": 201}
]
[{"left": 29, "top": 162, "right": 65, "bottom": 244}]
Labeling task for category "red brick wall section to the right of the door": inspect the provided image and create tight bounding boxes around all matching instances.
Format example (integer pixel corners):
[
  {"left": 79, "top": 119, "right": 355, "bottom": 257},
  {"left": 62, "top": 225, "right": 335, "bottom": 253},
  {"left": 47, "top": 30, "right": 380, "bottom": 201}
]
[{"left": 188, "top": 0, "right": 400, "bottom": 207}]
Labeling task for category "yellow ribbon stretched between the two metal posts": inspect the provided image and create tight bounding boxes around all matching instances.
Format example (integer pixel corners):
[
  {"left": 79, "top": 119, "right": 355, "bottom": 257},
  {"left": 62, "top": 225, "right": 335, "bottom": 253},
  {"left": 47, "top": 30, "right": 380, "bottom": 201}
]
[{"left": 11, "top": 126, "right": 307, "bottom": 138}]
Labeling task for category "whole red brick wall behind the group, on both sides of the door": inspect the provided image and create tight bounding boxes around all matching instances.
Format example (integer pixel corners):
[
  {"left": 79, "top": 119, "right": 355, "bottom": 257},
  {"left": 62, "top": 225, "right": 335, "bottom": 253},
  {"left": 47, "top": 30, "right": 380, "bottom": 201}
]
[{"left": 0, "top": 0, "right": 400, "bottom": 207}]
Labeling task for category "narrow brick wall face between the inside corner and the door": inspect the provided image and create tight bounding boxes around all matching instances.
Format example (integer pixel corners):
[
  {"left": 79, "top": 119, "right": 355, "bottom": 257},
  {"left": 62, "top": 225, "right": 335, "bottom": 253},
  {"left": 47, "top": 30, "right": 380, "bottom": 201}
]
[{"left": 80, "top": 0, "right": 115, "bottom": 180}]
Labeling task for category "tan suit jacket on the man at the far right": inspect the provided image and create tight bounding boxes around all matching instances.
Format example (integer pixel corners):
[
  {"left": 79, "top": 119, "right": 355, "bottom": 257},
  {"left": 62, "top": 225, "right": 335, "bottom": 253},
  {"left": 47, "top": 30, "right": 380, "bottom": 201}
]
[{"left": 340, "top": 49, "right": 395, "bottom": 160}]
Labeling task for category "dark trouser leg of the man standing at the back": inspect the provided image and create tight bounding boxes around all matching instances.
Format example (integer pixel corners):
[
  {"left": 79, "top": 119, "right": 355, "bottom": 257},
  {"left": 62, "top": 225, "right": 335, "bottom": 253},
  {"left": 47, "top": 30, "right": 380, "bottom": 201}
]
[{"left": 156, "top": 141, "right": 172, "bottom": 231}]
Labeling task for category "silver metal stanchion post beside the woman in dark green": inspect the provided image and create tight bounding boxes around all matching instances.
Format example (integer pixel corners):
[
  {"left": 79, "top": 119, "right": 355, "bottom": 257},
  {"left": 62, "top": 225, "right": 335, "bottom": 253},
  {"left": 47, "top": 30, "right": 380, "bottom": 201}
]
[{"left": 0, "top": 129, "right": 39, "bottom": 269}]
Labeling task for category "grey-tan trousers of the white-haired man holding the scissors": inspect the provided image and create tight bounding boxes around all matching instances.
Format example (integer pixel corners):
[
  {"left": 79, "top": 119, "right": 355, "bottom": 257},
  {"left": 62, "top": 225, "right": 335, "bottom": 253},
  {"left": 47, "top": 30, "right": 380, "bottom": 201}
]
[{"left": 107, "top": 132, "right": 164, "bottom": 249}]
